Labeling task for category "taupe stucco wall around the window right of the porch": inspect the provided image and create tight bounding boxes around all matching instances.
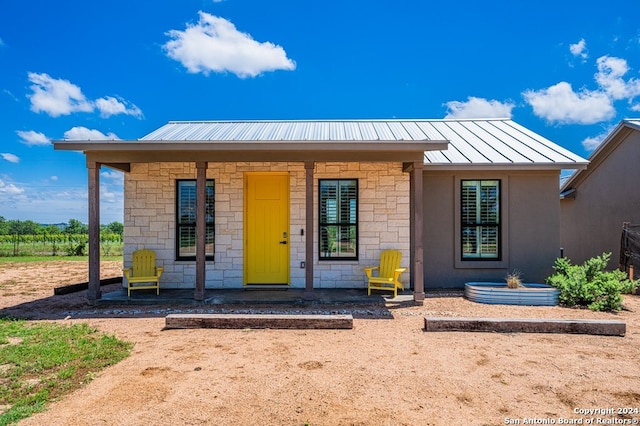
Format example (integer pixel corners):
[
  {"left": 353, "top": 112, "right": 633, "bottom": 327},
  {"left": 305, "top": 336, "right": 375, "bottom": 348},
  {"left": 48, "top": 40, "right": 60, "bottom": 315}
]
[{"left": 423, "top": 170, "right": 560, "bottom": 289}]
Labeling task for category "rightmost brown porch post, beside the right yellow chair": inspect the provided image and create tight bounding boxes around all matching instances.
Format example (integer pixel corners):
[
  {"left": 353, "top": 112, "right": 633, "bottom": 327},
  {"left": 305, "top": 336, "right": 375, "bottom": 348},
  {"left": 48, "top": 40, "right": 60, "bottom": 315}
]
[{"left": 406, "top": 162, "right": 424, "bottom": 305}]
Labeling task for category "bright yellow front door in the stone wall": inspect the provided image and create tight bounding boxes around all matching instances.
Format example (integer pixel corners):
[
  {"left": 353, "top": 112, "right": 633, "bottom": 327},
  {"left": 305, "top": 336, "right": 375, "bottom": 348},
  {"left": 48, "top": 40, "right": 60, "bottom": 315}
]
[{"left": 244, "top": 173, "right": 289, "bottom": 285}]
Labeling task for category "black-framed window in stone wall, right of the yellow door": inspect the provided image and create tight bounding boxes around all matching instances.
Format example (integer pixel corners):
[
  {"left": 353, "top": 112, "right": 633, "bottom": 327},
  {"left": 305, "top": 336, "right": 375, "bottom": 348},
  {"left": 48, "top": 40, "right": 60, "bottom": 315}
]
[{"left": 318, "top": 179, "right": 358, "bottom": 260}]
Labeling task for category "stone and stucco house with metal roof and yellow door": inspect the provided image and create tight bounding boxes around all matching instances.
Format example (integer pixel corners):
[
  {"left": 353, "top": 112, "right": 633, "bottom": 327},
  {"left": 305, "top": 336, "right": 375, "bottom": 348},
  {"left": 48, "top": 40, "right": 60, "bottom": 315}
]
[{"left": 54, "top": 119, "right": 587, "bottom": 302}]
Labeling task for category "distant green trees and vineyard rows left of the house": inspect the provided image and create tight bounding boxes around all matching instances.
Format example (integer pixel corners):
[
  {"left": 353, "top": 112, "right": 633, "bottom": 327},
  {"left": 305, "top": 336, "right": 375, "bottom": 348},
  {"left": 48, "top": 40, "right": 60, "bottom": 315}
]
[{"left": 0, "top": 216, "right": 124, "bottom": 256}]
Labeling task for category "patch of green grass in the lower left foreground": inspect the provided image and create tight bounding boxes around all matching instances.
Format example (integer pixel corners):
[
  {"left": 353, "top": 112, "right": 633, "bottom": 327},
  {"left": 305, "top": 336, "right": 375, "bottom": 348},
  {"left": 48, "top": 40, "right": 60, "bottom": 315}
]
[{"left": 0, "top": 319, "right": 133, "bottom": 425}]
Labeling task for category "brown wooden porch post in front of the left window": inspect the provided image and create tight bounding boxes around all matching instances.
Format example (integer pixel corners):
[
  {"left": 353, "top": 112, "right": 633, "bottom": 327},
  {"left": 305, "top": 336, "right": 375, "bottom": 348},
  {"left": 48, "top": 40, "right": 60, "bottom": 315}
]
[{"left": 193, "top": 161, "right": 207, "bottom": 300}]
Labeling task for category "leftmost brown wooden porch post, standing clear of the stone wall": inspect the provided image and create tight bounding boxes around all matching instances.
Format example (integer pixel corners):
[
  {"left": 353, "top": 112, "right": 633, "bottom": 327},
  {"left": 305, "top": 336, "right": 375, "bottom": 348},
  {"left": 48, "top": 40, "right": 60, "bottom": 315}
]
[{"left": 87, "top": 161, "right": 102, "bottom": 304}]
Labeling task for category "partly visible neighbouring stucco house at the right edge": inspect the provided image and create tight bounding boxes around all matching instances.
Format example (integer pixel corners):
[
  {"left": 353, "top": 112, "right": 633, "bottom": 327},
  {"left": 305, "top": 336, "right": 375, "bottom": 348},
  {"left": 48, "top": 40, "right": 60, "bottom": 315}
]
[{"left": 560, "top": 119, "right": 640, "bottom": 268}]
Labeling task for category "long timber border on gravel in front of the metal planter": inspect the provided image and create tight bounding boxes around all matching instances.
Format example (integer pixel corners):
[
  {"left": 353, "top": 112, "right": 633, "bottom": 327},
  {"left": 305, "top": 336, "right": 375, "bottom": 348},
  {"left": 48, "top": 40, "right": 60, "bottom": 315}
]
[{"left": 424, "top": 317, "right": 627, "bottom": 336}]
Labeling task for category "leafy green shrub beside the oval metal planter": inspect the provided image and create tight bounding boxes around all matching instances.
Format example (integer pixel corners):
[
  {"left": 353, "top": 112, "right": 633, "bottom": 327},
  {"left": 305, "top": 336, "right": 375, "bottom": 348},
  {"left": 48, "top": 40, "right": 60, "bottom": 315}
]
[{"left": 547, "top": 253, "right": 640, "bottom": 311}]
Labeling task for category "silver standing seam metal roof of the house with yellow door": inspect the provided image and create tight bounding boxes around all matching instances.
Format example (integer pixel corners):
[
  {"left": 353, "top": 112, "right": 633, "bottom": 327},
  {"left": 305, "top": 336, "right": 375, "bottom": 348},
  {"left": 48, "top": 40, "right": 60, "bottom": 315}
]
[{"left": 139, "top": 119, "right": 588, "bottom": 168}]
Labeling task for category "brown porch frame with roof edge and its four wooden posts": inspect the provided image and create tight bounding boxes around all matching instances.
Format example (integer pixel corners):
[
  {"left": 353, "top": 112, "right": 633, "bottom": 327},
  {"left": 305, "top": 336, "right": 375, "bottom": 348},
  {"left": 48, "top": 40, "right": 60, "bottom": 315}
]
[{"left": 54, "top": 121, "right": 447, "bottom": 304}]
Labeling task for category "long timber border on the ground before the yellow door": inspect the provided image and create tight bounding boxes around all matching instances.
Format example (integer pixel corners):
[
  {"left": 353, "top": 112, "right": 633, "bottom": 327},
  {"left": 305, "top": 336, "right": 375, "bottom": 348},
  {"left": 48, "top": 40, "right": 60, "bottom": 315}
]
[{"left": 165, "top": 314, "right": 353, "bottom": 329}]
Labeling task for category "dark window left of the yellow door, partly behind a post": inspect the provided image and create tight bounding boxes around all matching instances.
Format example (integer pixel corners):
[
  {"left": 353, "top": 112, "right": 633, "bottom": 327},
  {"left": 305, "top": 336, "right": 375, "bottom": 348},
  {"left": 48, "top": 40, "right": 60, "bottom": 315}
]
[{"left": 176, "top": 179, "right": 215, "bottom": 260}]
